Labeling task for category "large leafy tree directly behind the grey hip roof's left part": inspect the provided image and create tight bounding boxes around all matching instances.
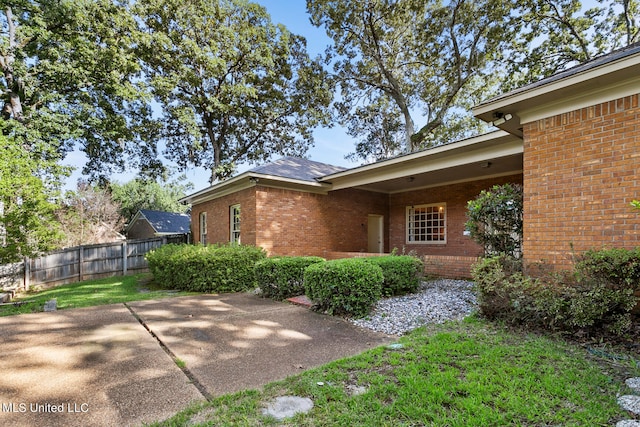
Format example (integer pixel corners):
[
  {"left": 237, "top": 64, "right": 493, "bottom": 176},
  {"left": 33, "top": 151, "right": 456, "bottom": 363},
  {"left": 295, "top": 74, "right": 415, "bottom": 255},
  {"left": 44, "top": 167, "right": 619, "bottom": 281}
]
[{"left": 135, "top": 0, "right": 331, "bottom": 182}]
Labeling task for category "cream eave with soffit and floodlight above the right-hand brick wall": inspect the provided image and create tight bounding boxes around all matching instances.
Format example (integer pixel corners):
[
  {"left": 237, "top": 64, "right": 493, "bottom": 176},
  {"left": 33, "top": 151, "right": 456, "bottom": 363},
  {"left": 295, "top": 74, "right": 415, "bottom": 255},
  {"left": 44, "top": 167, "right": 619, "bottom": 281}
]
[{"left": 473, "top": 43, "right": 640, "bottom": 137}]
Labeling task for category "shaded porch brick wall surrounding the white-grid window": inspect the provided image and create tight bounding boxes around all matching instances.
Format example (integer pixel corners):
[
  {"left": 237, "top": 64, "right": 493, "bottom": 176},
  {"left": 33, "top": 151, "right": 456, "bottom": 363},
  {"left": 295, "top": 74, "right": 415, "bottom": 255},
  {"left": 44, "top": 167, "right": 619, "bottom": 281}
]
[{"left": 389, "top": 175, "right": 522, "bottom": 258}]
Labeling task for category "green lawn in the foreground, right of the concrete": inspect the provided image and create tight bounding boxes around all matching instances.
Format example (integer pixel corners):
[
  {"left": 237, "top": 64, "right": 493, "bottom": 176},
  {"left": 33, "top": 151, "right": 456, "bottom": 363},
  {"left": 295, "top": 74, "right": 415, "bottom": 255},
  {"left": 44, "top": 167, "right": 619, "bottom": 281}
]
[{"left": 149, "top": 318, "right": 640, "bottom": 427}]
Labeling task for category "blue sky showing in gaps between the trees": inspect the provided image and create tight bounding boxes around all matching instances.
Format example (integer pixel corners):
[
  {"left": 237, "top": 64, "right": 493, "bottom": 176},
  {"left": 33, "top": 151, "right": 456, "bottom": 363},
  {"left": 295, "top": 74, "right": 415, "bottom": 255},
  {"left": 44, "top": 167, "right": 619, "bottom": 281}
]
[{"left": 65, "top": 0, "right": 358, "bottom": 190}]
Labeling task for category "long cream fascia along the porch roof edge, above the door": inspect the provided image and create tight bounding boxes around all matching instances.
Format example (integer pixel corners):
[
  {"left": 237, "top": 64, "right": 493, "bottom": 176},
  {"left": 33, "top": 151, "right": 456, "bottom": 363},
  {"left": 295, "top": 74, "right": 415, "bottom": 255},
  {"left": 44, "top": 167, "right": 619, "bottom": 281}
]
[{"left": 322, "top": 131, "right": 523, "bottom": 190}]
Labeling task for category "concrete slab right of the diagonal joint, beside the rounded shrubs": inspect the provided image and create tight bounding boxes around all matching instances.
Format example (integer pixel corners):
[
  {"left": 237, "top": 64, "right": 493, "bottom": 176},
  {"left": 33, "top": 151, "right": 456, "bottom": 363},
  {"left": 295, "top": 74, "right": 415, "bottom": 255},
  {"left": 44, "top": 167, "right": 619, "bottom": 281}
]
[{"left": 130, "top": 293, "right": 395, "bottom": 396}]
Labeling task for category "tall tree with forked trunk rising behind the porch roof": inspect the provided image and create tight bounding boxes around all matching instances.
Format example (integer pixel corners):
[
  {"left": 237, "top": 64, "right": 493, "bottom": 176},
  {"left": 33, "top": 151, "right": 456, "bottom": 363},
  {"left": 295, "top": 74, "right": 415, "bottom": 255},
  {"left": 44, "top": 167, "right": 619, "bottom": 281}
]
[{"left": 307, "top": 0, "right": 513, "bottom": 152}]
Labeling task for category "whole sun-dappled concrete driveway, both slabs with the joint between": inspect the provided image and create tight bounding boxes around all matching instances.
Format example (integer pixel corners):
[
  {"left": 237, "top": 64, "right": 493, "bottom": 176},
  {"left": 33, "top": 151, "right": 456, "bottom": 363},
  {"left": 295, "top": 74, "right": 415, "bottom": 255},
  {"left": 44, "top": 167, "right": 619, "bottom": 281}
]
[{"left": 0, "top": 293, "right": 395, "bottom": 426}]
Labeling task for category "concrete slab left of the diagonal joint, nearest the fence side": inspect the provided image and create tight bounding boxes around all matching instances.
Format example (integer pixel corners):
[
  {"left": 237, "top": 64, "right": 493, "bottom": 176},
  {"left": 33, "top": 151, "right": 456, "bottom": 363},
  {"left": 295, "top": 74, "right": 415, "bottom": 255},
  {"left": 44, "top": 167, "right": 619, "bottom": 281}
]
[{"left": 0, "top": 304, "right": 202, "bottom": 426}]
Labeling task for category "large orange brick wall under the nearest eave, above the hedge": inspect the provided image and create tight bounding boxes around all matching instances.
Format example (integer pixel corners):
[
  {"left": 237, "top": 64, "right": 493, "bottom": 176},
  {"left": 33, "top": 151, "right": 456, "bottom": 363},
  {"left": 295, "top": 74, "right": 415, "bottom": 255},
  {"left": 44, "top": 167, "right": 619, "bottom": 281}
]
[{"left": 523, "top": 95, "right": 640, "bottom": 268}]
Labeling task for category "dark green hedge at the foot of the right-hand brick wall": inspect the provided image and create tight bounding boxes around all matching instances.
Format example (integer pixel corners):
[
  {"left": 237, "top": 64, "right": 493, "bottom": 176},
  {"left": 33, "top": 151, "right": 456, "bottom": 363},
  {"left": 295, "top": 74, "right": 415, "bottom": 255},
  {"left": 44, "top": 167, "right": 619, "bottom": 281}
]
[{"left": 472, "top": 251, "right": 639, "bottom": 335}]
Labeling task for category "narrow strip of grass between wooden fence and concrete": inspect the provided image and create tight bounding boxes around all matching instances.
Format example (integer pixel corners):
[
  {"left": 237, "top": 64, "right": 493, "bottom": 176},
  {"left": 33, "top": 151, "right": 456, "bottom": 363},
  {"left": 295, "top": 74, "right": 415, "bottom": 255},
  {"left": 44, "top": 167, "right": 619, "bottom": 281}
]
[{"left": 0, "top": 274, "right": 191, "bottom": 316}]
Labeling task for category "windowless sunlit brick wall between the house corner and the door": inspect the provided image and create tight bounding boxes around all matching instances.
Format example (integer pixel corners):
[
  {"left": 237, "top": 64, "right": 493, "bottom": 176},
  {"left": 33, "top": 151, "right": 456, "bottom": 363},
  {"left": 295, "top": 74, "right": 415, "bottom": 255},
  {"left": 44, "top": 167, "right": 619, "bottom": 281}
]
[{"left": 256, "top": 187, "right": 388, "bottom": 256}]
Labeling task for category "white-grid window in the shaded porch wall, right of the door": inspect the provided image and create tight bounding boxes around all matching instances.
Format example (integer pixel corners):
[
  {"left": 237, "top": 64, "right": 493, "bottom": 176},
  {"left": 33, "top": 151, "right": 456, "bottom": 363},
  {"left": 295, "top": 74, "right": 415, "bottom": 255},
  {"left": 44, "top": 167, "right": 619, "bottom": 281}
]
[{"left": 405, "top": 202, "right": 447, "bottom": 245}]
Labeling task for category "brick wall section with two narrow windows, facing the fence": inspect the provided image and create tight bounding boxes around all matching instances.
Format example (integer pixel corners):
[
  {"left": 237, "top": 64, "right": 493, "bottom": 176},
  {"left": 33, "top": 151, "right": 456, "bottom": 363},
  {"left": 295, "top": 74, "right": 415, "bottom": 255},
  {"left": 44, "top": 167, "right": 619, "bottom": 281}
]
[{"left": 191, "top": 188, "right": 256, "bottom": 245}]
